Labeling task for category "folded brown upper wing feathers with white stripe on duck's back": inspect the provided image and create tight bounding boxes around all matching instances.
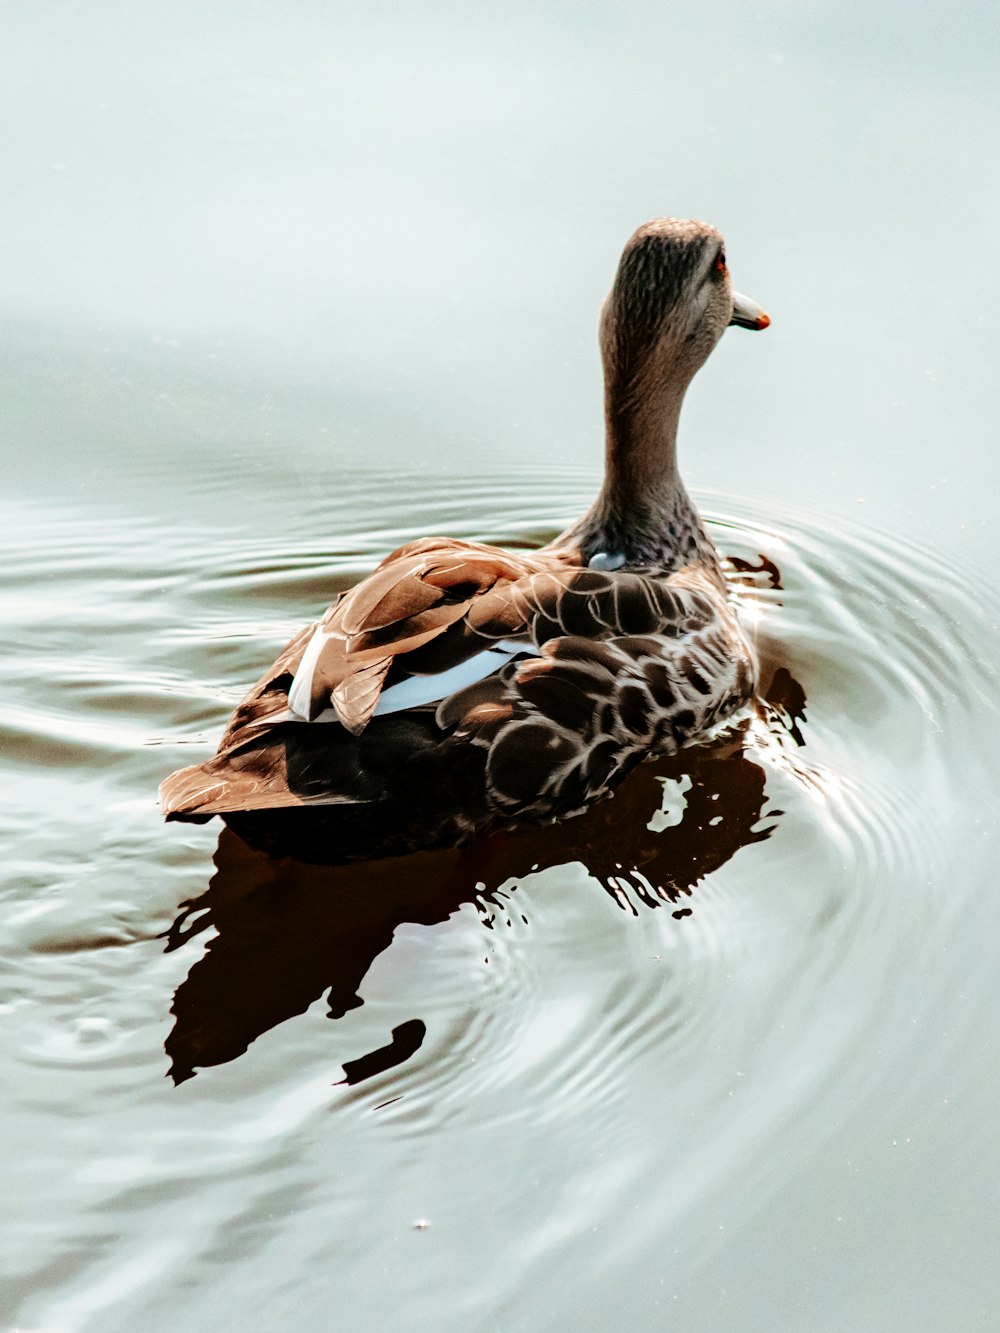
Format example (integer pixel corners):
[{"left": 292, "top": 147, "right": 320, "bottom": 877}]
[{"left": 288, "top": 539, "right": 725, "bottom": 734}]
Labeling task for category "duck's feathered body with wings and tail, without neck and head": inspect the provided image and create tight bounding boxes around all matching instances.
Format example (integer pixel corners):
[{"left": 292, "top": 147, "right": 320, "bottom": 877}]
[{"left": 160, "top": 539, "right": 753, "bottom": 860}]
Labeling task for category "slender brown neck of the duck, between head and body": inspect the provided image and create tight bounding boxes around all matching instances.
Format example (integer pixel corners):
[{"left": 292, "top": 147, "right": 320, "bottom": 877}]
[{"left": 573, "top": 376, "right": 717, "bottom": 571}]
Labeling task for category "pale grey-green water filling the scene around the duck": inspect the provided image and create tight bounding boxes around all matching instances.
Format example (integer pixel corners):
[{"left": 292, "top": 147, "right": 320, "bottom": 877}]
[{"left": 0, "top": 0, "right": 1000, "bottom": 1330}]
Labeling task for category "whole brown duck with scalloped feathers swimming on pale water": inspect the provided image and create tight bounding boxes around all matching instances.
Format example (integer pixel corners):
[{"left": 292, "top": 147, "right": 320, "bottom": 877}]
[{"left": 160, "top": 217, "right": 771, "bottom": 864}]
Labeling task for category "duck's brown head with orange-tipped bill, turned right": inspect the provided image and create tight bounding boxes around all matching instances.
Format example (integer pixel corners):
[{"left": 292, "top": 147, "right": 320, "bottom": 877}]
[{"left": 601, "top": 217, "right": 771, "bottom": 399}]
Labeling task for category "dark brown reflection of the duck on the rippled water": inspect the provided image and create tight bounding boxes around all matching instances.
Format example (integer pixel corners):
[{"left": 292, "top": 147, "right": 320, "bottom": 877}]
[{"left": 165, "top": 668, "right": 805, "bottom": 1084}]
